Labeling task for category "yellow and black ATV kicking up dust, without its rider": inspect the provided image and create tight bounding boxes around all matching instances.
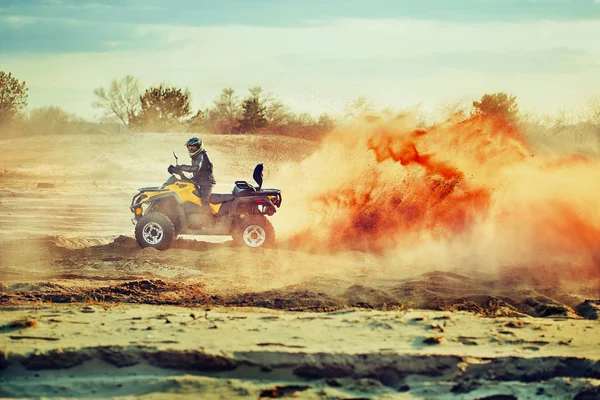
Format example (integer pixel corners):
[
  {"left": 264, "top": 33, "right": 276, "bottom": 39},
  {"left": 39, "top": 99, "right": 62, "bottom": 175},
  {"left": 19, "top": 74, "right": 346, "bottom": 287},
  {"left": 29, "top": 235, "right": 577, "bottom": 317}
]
[{"left": 130, "top": 153, "right": 281, "bottom": 250}]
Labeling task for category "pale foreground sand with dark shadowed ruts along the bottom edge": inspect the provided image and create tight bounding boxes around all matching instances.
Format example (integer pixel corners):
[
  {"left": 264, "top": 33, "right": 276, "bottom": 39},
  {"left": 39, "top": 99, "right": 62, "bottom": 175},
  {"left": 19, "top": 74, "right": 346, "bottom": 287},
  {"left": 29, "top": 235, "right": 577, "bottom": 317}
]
[{"left": 0, "top": 304, "right": 600, "bottom": 399}]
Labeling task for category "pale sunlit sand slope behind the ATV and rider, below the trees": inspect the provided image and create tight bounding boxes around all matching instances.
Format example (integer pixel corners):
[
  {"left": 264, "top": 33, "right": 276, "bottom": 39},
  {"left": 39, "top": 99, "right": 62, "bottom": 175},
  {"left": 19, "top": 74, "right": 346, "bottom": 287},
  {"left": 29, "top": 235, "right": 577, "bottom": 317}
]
[{"left": 0, "top": 133, "right": 317, "bottom": 241}]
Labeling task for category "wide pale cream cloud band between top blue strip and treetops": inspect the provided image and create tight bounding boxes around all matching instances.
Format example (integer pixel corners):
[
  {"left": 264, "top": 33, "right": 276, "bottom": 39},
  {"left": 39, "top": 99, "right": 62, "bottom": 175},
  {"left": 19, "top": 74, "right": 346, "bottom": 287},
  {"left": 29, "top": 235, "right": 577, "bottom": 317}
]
[{"left": 0, "top": 18, "right": 600, "bottom": 116}]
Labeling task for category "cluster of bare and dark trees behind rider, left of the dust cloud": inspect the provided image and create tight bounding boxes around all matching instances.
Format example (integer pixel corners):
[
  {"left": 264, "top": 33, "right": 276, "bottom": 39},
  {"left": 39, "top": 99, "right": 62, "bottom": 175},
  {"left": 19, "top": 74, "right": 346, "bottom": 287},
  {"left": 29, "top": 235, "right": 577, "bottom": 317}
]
[{"left": 93, "top": 75, "right": 335, "bottom": 137}]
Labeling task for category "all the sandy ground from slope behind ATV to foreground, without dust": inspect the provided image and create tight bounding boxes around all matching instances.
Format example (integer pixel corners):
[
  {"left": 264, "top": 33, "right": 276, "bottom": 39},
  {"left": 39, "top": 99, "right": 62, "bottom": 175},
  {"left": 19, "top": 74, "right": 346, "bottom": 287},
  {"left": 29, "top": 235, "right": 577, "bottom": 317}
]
[{"left": 0, "top": 133, "right": 600, "bottom": 399}]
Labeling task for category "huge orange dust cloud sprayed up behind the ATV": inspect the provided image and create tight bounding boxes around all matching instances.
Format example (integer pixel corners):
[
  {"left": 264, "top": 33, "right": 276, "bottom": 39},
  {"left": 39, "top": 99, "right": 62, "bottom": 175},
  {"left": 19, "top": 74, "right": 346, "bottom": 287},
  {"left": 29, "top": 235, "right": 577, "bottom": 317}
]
[{"left": 275, "top": 113, "right": 600, "bottom": 280}]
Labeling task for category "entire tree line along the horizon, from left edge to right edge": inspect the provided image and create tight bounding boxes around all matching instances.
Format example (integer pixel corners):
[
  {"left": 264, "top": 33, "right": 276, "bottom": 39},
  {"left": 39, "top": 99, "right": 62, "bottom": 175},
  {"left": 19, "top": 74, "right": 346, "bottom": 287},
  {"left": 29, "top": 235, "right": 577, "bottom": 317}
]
[{"left": 0, "top": 71, "right": 600, "bottom": 140}]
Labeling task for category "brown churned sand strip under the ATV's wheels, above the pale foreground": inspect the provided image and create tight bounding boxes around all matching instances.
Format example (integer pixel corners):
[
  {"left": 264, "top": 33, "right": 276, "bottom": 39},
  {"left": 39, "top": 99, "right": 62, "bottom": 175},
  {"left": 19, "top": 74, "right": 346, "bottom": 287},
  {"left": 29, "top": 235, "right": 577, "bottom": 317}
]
[{"left": 0, "top": 236, "right": 600, "bottom": 319}]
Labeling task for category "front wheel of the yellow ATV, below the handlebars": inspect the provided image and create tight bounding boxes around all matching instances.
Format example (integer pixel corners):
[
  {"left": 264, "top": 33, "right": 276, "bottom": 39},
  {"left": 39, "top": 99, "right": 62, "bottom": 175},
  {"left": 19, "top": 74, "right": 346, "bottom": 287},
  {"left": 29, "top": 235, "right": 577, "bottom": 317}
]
[{"left": 135, "top": 212, "right": 177, "bottom": 250}]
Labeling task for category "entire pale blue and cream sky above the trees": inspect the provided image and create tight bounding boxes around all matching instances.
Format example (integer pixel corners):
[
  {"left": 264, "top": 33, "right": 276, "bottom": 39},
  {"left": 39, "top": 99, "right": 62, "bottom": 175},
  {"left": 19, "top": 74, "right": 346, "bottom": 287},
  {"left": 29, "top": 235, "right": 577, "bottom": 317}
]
[{"left": 0, "top": 0, "right": 600, "bottom": 119}]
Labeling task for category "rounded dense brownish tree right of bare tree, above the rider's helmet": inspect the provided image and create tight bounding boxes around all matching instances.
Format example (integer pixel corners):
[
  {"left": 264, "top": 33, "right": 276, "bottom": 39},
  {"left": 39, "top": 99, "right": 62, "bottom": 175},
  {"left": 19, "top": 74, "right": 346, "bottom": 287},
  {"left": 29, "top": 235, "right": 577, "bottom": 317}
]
[{"left": 130, "top": 84, "right": 192, "bottom": 131}]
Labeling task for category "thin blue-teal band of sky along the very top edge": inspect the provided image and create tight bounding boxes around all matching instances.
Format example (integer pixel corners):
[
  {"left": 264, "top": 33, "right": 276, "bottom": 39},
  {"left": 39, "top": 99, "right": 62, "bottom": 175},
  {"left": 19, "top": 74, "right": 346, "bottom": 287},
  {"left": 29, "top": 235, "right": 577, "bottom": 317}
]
[{"left": 0, "top": 0, "right": 600, "bottom": 27}]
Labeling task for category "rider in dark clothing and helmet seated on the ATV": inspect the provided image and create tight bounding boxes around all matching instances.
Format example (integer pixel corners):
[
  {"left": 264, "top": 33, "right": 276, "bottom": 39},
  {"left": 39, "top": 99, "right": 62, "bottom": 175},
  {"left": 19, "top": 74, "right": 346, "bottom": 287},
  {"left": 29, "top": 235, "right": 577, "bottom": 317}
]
[{"left": 175, "top": 137, "right": 217, "bottom": 209}]
